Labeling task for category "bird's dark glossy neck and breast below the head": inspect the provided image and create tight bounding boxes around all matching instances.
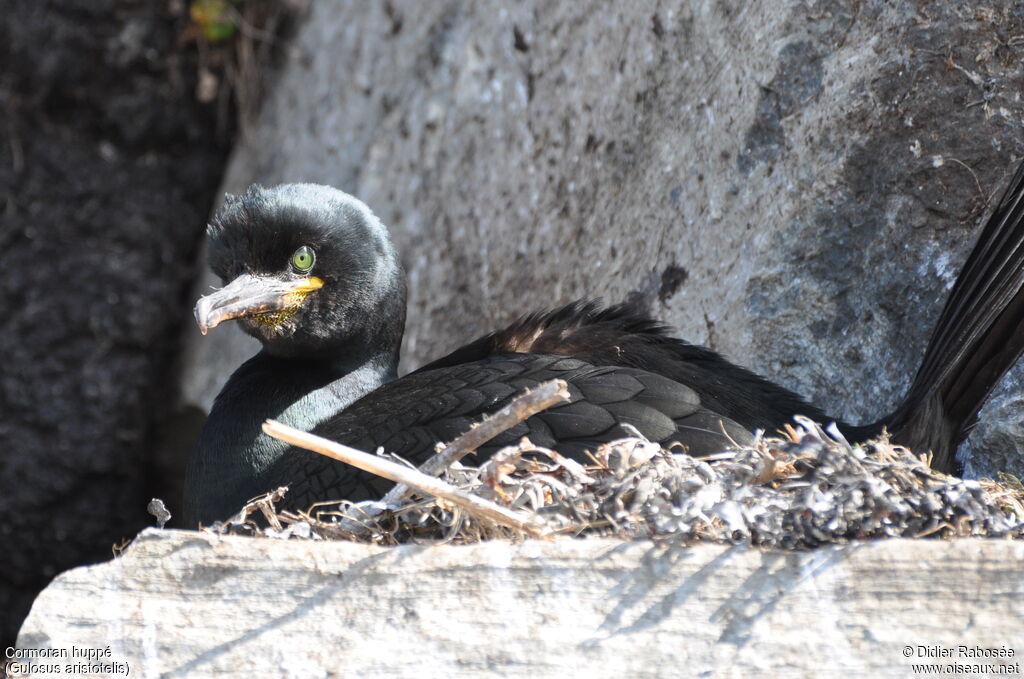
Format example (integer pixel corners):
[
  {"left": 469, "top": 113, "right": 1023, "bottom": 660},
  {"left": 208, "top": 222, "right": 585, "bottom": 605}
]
[{"left": 184, "top": 351, "right": 397, "bottom": 526}]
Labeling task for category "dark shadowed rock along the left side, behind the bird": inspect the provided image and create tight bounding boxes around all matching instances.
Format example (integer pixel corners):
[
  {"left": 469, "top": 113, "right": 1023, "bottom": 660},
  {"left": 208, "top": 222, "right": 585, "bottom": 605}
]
[{"left": 0, "top": 0, "right": 227, "bottom": 646}]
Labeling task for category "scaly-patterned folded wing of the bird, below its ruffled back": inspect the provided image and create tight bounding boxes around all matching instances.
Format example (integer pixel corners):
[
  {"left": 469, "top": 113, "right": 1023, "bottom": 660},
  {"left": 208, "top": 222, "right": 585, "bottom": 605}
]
[{"left": 266, "top": 353, "right": 751, "bottom": 508}]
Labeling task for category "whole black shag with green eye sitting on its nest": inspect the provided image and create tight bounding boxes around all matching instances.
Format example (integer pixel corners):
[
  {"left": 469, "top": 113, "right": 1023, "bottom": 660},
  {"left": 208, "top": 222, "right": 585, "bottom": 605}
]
[{"left": 184, "top": 167, "right": 1024, "bottom": 525}]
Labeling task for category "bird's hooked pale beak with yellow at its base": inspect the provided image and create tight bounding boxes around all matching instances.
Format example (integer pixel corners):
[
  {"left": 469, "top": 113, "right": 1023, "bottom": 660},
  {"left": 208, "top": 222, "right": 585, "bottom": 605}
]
[{"left": 195, "top": 273, "right": 324, "bottom": 335}]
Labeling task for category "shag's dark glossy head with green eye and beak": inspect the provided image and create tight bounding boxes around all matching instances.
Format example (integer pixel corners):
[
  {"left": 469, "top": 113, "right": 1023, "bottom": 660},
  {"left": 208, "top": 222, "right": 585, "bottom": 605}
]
[{"left": 195, "top": 184, "right": 406, "bottom": 360}]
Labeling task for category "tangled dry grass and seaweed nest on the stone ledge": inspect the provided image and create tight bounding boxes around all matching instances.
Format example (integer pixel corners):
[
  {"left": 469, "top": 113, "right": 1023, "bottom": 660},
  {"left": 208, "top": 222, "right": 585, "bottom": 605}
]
[{"left": 208, "top": 420, "right": 1024, "bottom": 549}]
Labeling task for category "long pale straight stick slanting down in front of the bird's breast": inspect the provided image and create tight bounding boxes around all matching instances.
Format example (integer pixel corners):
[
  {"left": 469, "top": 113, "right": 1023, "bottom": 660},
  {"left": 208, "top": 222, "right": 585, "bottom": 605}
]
[{"left": 263, "top": 420, "right": 545, "bottom": 537}]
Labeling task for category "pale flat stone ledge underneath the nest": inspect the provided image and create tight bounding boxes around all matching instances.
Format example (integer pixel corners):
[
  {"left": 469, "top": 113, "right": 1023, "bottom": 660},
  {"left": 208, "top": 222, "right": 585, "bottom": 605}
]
[{"left": 17, "top": 529, "right": 1024, "bottom": 679}]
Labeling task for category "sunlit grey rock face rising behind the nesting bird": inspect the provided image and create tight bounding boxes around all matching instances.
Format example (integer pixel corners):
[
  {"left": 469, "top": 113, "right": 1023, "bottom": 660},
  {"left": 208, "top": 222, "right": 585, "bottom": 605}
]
[{"left": 178, "top": 0, "right": 1024, "bottom": 473}]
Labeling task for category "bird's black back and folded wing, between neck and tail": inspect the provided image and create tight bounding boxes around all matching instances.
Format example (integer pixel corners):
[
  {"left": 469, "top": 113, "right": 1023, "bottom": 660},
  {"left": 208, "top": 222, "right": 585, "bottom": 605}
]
[{"left": 267, "top": 301, "right": 828, "bottom": 507}]
